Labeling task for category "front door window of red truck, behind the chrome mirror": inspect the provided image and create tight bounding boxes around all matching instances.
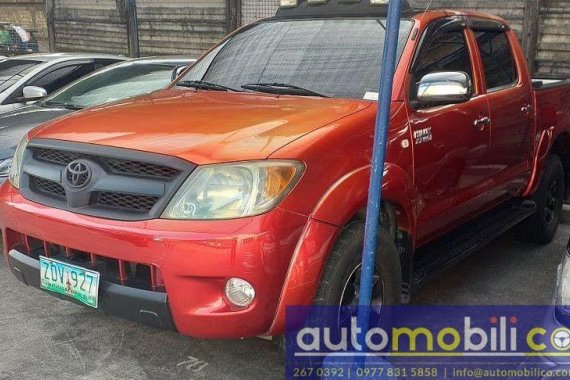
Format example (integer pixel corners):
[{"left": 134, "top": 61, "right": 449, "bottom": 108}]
[{"left": 410, "top": 30, "right": 473, "bottom": 101}]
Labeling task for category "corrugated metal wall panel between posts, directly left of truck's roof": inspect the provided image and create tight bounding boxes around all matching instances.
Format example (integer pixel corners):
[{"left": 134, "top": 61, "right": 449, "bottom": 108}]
[{"left": 137, "top": 0, "right": 227, "bottom": 56}]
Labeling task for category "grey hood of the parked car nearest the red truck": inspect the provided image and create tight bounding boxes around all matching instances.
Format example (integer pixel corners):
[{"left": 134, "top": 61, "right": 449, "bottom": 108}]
[{"left": 0, "top": 105, "right": 74, "bottom": 160}]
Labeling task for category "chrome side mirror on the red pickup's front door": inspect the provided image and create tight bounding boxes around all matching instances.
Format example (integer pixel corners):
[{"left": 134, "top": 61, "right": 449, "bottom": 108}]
[{"left": 417, "top": 71, "right": 473, "bottom": 106}]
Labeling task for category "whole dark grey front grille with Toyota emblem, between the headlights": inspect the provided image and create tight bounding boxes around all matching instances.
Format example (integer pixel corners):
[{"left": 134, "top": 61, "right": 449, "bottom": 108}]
[{"left": 20, "top": 139, "right": 196, "bottom": 221}]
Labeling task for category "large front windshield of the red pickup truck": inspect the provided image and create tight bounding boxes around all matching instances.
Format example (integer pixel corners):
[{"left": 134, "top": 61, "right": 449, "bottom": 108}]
[{"left": 180, "top": 18, "right": 413, "bottom": 99}]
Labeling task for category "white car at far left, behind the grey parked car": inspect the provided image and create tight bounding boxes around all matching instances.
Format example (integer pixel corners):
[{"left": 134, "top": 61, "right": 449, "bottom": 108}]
[{"left": 0, "top": 53, "right": 126, "bottom": 114}]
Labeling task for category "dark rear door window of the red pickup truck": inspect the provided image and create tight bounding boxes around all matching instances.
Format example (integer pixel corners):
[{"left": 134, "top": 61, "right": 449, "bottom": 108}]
[{"left": 475, "top": 31, "right": 518, "bottom": 90}]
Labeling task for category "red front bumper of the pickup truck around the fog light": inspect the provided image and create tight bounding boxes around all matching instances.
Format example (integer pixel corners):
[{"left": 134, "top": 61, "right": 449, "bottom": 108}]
[{"left": 0, "top": 183, "right": 308, "bottom": 338}]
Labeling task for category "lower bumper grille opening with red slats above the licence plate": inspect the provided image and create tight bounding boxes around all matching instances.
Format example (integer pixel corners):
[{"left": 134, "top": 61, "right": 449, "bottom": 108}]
[{"left": 7, "top": 230, "right": 165, "bottom": 292}]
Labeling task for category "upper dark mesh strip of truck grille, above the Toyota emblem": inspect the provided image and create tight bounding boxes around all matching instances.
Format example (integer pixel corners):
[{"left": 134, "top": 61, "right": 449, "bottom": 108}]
[{"left": 34, "top": 148, "right": 180, "bottom": 179}]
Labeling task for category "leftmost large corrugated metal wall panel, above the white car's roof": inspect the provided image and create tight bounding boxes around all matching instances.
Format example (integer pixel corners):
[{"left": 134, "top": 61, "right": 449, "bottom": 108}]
[{"left": 54, "top": 0, "right": 128, "bottom": 55}]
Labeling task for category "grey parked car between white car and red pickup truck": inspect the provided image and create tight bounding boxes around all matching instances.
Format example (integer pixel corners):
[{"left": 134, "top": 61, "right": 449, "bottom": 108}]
[{"left": 0, "top": 57, "right": 195, "bottom": 184}]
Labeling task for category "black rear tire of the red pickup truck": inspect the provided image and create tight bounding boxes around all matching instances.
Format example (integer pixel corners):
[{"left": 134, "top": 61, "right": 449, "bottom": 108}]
[{"left": 518, "top": 155, "right": 565, "bottom": 245}]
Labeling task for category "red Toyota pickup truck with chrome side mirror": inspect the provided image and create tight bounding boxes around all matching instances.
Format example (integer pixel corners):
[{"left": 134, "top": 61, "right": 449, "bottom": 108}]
[{"left": 0, "top": 0, "right": 570, "bottom": 338}]
